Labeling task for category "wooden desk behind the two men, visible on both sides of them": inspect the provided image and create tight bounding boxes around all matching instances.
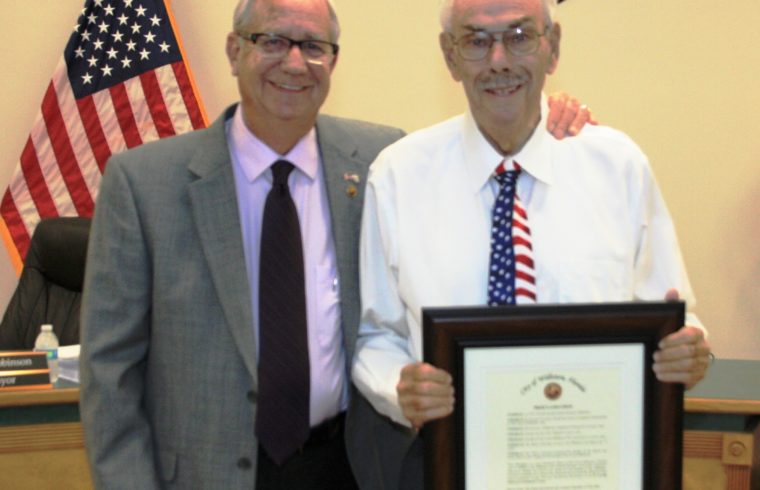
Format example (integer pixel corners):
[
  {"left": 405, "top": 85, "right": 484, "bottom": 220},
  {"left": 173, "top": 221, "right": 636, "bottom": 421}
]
[{"left": 0, "top": 360, "right": 760, "bottom": 490}]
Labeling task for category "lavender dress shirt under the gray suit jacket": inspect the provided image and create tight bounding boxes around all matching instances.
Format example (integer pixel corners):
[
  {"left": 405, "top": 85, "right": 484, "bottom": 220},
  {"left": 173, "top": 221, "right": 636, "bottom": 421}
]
[{"left": 227, "top": 107, "right": 348, "bottom": 427}]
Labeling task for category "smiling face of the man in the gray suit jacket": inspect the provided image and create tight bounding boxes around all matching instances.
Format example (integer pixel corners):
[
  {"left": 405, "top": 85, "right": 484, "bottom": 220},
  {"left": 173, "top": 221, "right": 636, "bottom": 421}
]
[{"left": 227, "top": 0, "right": 336, "bottom": 133}]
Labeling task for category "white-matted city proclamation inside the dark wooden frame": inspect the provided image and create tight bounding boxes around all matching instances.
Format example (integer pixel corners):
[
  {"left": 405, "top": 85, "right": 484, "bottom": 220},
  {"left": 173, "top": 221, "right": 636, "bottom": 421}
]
[{"left": 464, "top": 344, "right": 645, "bottom": 490}]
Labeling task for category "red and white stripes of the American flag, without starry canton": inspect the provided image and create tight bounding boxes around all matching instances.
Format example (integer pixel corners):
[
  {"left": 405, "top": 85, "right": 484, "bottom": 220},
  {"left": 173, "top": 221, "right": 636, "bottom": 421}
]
[{"left": 0, "top": 60, "right": 205, "bottom": 260}]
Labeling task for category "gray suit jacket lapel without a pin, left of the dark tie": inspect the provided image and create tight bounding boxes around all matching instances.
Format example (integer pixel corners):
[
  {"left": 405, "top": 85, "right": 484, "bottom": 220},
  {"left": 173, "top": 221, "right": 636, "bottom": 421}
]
[{"left": 188, "top": 106, "right": 257, "bottom": 386}]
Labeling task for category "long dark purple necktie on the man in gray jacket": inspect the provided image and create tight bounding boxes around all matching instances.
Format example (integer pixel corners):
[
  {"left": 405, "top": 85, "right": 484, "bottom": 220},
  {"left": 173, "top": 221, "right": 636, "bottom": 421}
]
[{"left": 256, "top": 160, "right": 310, "bottom": 464}]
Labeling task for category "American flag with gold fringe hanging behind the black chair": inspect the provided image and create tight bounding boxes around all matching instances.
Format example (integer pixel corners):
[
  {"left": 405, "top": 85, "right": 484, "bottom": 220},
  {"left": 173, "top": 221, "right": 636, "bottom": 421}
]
[{"left": 0, "top": 0, "right": 206, "bottom": 269}]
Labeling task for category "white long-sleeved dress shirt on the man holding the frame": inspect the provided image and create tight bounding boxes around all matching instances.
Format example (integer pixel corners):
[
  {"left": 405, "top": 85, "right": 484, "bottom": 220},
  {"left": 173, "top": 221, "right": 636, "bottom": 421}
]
[{"left": 352, "top": 107, "right": 699, "bottom": 426}]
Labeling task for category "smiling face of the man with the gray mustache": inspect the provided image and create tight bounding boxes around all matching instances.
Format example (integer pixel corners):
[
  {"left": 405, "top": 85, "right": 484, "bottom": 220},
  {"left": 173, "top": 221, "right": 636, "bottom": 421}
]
[{"left": 440, "top": 0, "right": 560, "bottom": 149}]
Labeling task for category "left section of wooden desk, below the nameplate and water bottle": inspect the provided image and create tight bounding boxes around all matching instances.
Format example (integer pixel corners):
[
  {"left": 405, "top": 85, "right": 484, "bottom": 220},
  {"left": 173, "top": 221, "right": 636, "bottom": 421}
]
[{"left": 0, "top": 381, "right": 92, "bottom": 490}]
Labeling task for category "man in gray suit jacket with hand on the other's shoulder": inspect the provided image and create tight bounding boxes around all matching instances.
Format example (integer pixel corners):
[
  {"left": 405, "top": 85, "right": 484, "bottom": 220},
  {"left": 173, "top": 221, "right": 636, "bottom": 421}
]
[{"left": 81, "top": 0, "right": 588, "bottom": 490}]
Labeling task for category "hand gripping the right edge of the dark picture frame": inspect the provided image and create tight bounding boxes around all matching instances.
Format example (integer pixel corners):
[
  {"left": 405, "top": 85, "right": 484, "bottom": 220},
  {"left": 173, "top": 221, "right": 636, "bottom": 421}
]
[{"left": 654, "top": 326, "right": 710, "bottom": 389}]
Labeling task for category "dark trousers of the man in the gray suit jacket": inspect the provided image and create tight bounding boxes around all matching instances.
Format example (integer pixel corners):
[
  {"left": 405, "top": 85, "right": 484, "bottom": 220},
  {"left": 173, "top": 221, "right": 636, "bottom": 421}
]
[{"left": 256, "top": 415, "right": 359, "bottom": 490}]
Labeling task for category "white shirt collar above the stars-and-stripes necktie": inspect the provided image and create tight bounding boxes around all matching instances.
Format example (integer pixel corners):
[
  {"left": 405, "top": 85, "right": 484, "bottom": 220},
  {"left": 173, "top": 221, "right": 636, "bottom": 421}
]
[{"left": 462, "top": 97, "right": 554, "bottom": 193}]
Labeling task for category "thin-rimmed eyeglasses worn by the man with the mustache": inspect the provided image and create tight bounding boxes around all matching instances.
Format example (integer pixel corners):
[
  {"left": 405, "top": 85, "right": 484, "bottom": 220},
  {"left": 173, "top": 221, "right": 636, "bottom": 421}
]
[{"left": 451, "top": 27, "right": 549, "bottom": 61}]
